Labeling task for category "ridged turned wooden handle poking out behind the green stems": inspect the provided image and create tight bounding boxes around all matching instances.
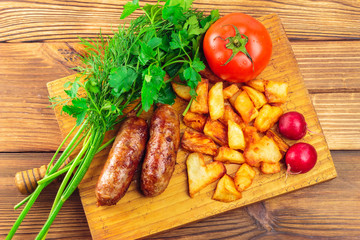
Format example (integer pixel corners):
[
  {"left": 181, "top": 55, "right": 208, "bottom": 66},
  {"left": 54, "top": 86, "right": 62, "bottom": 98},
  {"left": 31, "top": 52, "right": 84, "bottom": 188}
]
[{"left": 15, "top": 158, "right": 70, "bottom": 194}]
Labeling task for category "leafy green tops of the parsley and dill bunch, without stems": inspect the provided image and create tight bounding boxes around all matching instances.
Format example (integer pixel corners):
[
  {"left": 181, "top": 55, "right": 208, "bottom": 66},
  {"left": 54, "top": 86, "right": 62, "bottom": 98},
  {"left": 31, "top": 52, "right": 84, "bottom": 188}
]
[{"left": 68, "top": 0, "right": 219, "bottom": 127}]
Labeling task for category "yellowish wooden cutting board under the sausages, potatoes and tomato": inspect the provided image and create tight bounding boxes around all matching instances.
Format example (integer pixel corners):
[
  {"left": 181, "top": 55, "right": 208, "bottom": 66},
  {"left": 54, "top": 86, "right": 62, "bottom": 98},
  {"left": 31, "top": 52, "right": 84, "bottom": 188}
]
[{"left": 48, "top": 15, "right": 336, "bottom": 239}]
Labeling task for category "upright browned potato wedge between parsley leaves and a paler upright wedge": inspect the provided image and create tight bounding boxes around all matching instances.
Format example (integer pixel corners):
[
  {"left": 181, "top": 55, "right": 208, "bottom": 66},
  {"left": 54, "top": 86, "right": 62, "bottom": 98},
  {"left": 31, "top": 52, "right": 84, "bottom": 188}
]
[{"left": 190, "top": 78, "right": 209, "bottom": 114}]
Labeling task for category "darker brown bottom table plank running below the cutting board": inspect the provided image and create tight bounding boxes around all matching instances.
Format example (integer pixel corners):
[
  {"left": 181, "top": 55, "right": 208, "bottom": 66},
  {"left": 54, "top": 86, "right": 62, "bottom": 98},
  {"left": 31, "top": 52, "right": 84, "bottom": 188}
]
[{"left": 0, "top": 151, "right": 360, "bottom": 240}]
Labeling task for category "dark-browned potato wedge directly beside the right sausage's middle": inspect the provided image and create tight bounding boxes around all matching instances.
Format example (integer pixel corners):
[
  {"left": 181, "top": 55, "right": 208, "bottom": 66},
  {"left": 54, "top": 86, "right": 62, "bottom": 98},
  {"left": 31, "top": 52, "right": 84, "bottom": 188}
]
[{"left": 181, "top": 129, "right": 217, "bottom": 156}]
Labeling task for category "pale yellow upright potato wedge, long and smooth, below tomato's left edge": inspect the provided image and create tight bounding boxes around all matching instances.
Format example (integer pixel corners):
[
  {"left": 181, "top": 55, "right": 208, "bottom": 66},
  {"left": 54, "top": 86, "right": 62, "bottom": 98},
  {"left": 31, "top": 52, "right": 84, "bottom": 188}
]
[{"left": 209, "top": 82, "right": 225, "bottom": 120}]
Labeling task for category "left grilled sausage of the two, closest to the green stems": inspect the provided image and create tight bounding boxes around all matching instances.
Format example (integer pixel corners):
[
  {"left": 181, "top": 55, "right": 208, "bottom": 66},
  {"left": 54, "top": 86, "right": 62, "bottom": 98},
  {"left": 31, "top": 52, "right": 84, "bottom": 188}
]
[{"left": 95, "top": 117, "right": 148, "bottom": 206}]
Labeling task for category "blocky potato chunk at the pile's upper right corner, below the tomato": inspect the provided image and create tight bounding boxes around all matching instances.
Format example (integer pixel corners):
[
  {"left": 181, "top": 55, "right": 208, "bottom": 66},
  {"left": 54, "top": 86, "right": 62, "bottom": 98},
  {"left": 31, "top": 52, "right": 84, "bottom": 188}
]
[{"left": 265, "top": 81, "right": 288, "bottom": 104}]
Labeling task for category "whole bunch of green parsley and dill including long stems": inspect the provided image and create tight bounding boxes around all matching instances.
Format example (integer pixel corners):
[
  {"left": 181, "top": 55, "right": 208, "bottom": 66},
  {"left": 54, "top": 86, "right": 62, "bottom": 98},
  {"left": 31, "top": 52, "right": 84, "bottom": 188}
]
[{"left": 6, "top": 0, "right": 219, "bottom": 239}]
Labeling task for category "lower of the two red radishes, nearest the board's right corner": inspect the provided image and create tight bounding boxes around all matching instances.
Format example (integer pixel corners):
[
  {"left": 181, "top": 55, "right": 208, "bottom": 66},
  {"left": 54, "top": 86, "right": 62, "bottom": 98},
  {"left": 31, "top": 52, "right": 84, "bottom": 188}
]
[{"left": 285, "top": 142, "right": 317, "bottom": 174}]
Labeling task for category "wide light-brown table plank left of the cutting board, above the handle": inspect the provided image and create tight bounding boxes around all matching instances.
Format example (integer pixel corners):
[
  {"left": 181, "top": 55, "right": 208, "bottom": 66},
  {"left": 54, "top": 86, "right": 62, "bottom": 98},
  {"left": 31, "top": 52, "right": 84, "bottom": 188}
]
[{"left": 0, "top": 43, "right": 84, "bottom": 152}]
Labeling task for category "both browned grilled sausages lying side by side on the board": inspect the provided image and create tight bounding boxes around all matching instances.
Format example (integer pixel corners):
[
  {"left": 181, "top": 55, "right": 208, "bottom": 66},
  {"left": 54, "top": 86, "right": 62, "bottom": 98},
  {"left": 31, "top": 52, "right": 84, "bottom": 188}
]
[{"left": 95, "top": 104, "right": 180, "bottom": 206}]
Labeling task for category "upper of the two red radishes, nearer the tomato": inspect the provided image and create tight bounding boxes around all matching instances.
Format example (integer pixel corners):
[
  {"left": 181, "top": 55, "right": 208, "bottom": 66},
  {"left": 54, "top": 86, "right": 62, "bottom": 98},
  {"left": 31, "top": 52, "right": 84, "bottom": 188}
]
[{"left": 278, "top": 111, "right": 307, "bottom": 140}]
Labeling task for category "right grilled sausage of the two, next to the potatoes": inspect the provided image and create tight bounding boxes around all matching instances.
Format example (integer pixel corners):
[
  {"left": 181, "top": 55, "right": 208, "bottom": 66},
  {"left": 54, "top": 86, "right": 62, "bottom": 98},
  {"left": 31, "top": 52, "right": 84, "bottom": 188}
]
[{"left": 140, "top": 104, "right": 180, "bottom": 197}]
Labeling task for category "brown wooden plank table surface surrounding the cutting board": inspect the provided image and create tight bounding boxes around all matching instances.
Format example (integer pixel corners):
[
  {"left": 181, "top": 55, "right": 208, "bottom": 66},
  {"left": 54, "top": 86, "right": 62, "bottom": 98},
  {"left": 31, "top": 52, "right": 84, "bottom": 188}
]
[{"left": 0, "top": 0, "right": 360, "bottom": 239}]
